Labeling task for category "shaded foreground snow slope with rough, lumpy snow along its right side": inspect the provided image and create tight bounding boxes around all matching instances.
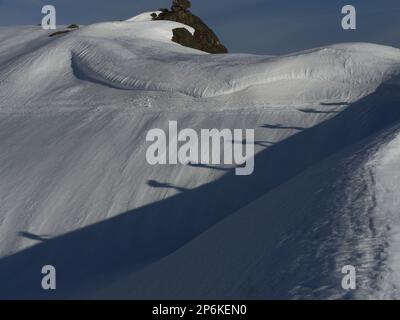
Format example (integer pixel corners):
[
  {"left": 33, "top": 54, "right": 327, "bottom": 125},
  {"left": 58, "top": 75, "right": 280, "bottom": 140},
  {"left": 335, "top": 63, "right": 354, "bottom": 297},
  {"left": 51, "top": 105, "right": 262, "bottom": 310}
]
[{"left": 95, "top": 98, "right": 400, "bottom": 299}]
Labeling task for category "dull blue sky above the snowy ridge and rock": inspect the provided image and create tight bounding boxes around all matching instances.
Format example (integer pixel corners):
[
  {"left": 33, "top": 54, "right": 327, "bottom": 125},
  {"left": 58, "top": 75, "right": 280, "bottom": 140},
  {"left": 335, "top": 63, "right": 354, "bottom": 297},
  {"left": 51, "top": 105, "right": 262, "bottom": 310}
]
[{"left": 0, "top": 0, "right": 400, "bottom": 54}]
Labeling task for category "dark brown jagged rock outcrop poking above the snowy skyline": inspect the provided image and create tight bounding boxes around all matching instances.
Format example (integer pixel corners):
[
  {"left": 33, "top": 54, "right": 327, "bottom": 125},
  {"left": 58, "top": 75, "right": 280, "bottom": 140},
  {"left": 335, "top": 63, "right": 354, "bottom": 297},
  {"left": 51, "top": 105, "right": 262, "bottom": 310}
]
[{"left": 153, "top": 0, "right": 228, "bottom": 53}]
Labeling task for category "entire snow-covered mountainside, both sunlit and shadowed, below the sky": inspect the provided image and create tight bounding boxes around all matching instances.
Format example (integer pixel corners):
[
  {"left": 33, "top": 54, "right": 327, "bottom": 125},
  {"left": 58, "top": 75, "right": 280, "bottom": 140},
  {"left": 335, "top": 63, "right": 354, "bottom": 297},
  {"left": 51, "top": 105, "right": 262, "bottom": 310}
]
[{"left": 0, "top": 13, "right": 400, "bottom": 299}]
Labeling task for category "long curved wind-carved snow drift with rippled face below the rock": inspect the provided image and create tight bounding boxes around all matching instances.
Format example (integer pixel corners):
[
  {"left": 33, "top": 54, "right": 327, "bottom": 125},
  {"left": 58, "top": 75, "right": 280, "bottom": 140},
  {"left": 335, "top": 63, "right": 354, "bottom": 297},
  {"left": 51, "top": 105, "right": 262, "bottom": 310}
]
[{"left": 73, "top": 41, "right": 400, "bottom": 97}]
